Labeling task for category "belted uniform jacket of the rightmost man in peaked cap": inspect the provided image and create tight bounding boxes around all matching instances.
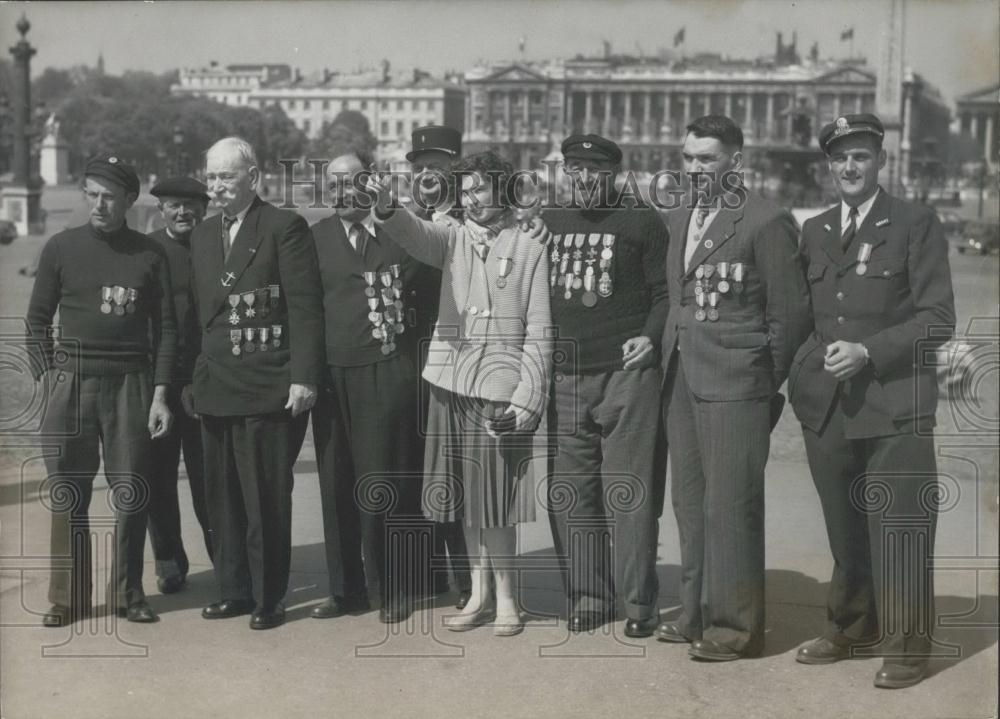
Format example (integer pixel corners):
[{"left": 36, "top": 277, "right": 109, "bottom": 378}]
[{"left": 788, "top": 190, "right": 955, "bottom": 438}]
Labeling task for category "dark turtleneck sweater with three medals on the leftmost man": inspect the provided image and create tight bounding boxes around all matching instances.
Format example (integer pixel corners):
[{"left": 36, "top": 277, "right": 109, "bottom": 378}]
[{"left": 27, "top": 224, "right": 177, "bottom": 384}]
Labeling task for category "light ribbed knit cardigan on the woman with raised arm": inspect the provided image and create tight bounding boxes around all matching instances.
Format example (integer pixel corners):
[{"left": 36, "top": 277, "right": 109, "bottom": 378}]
[{"left": 380, "top": 210, "right": 554, "bottom": 416}]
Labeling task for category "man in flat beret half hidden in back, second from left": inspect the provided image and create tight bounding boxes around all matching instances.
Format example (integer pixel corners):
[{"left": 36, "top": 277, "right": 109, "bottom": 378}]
[{"left": 149, "top": 177, "right": 212, "bottom": 594}]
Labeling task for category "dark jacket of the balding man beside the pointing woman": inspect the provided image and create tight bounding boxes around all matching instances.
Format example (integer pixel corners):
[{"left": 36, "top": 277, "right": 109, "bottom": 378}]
[{"left": 311, "top": 215, "right": 441, "bottom": 367}]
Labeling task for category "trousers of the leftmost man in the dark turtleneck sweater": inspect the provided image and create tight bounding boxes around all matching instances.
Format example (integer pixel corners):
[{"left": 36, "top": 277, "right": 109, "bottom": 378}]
[{"left": 42, "top": 370, "right": 153, "bottom": 608}]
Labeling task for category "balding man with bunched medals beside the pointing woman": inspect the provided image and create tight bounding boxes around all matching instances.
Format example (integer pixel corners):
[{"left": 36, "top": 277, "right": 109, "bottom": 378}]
[{"left": 312, "top": 151, "right": 437, "bottom": 622}]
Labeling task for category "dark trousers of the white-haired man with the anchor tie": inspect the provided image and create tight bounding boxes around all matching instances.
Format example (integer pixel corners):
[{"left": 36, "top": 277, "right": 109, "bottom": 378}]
[{"left": 202, "top": 410, "right": 309, "bottom": 609}]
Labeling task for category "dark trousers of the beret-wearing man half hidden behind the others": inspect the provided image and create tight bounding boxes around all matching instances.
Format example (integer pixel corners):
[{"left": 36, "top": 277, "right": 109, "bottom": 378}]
[{"left": 149, "top": 387, "right": 212, "bottom": 577}]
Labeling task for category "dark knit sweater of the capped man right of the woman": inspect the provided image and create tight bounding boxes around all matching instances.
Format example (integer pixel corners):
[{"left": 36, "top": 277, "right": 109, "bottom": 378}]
[{"left": 543, "top": 198, "right": 668, "bottom": 374}]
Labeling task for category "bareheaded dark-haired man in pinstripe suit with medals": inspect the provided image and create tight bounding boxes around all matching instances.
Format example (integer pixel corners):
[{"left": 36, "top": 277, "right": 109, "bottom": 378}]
[{"left": 656, "top": 115, "right": 810, "bottom": 661}]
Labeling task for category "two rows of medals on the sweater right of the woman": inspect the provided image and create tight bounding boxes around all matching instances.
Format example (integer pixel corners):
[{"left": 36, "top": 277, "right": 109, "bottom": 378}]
[{"left": 549, "top": 232, "right": 615, "bottom": 307}]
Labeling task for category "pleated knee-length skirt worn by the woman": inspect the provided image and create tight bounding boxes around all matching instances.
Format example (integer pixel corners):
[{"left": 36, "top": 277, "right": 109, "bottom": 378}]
[{"left": 421, "top": 385, "right": 535, "bottom": 529}]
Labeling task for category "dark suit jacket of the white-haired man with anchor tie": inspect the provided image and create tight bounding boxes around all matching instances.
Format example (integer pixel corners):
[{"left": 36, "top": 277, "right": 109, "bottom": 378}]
[{"left": 189, "top": 197, "right": 325, "bottom": 416}]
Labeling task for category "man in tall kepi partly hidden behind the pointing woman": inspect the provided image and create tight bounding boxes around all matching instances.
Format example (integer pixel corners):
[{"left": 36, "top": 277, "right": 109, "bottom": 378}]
[{"left": 404, "top": 125, "right": 472, "bottom": 609}]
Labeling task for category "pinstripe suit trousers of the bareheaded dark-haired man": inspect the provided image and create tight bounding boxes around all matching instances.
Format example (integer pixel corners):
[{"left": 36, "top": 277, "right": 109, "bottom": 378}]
[{"left": 664, "top": 353, "right": 771, "bottom": 655}]
